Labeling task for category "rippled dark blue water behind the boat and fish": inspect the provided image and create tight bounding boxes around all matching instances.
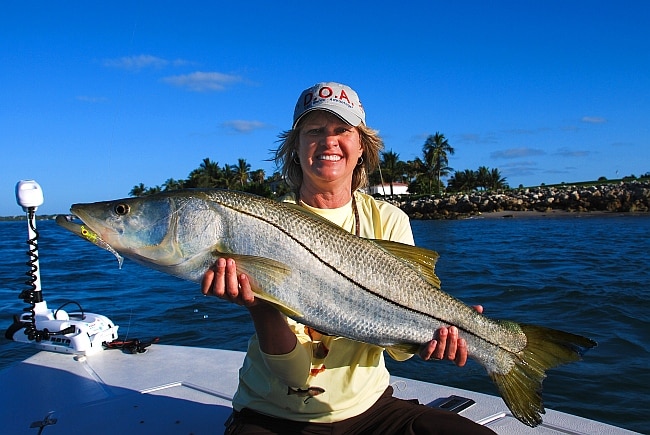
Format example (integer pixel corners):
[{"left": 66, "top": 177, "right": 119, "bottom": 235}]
[{"left": 0, "top": 215, "right": 650, "bottom": 433}]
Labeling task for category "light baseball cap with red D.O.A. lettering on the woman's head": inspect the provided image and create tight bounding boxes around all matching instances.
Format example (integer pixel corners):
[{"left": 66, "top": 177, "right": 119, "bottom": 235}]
[{"left": 292, "top": 82, "right": 366, "bottom": 128}]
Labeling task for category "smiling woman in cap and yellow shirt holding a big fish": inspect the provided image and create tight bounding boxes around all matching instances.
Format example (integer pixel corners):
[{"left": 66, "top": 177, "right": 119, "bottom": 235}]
[{"left": 202, "top": 82, "right": 492, "bottom": 435}]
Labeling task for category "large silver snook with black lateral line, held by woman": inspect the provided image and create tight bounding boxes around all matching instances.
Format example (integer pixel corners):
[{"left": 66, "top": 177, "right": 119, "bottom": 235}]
[{"left": 71, "top": 190, "right": 596, "bottom": 426}]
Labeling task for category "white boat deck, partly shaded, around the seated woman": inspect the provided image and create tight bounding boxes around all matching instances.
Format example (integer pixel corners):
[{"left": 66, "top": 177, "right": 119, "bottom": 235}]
[{"left": 0, "top": 345, "right": 634, "bottom": 435}]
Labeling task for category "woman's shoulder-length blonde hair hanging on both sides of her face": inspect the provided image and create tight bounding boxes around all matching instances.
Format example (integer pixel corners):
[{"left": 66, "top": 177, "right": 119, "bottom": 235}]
[{"left": 274, "top": 118, "right": 384, "bottom": 192}]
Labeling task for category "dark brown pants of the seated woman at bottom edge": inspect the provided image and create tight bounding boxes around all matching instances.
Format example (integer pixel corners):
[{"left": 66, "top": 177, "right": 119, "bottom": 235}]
[{"left": 225, "top": 387, "right": 494, "bottom": 435}]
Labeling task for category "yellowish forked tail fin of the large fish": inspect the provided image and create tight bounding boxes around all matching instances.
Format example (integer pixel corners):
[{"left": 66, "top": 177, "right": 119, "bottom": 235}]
[{"left": 490, "top": 324, "right": 596, "bottom": 427}]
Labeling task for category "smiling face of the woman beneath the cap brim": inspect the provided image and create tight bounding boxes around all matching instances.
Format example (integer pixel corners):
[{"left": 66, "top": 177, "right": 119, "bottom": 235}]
[{"left": 298, "top": 110, "right": 363, "bottom": 189}]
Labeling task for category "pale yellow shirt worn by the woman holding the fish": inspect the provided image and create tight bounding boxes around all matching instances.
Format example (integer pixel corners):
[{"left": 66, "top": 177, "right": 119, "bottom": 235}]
[{"left": 233, "top": 192, "right": 414, "bottom": 423}]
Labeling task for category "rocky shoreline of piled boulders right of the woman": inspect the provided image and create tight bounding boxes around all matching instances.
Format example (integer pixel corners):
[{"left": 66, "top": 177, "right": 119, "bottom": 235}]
[{"left": 392, "top": 181, "right": 650, "bottom": 220}]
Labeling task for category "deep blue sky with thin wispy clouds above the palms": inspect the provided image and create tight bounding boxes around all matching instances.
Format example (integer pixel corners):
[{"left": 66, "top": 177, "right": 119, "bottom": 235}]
[{"left": 0, "top": 0, "right": 650, "bottom": 216}]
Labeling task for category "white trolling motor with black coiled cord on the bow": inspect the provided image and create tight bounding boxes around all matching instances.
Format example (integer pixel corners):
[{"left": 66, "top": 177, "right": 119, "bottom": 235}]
[{"left": 5, "top": 180, "right": 118, "bottom": 355}]
